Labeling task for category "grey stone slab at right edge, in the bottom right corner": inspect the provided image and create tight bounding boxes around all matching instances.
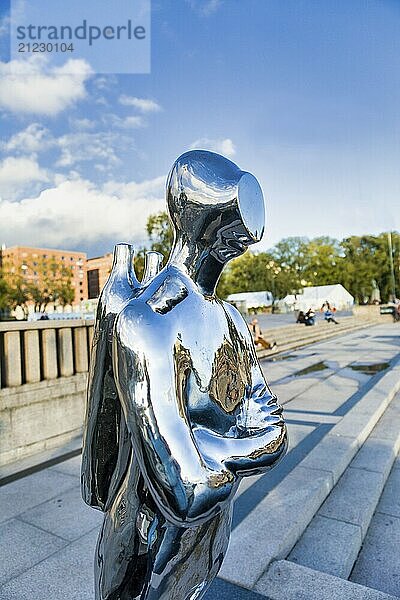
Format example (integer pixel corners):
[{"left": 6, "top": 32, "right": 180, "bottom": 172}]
[{"left": 351, "top": 512, "right": 400, "bottom": 596}]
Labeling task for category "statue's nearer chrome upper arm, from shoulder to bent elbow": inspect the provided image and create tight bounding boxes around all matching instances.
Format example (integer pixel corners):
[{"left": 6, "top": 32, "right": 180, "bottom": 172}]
[{"left": 114, "top": 307, "right": 237, "bottom": 526}]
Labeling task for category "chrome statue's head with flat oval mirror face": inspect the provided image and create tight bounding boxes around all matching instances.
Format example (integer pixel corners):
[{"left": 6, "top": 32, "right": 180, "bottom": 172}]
[{"left": 167, "top": 150, "right": 265, "bottom": 265}]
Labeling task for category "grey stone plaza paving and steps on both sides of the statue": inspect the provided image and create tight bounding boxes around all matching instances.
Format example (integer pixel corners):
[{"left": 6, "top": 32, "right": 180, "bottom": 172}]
[{"left": 0, "top": 324, "right": 400, "bottom": 600}]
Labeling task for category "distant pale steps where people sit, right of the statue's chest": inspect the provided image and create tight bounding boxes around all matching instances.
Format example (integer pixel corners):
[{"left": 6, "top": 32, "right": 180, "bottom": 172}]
[{"left": 257, "top": 313, "right": 392, "bottom": 358}]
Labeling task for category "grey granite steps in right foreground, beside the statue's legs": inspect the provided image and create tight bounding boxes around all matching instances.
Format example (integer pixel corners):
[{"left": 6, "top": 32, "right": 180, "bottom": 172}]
[{"left": 219, "top": 361, "right": 400, "bottom": 600}]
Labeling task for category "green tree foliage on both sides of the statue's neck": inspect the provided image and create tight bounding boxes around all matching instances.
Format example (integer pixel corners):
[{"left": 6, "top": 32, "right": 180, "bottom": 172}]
[{"left": 142, "top": 212, "right": 400, "bottom": 304}]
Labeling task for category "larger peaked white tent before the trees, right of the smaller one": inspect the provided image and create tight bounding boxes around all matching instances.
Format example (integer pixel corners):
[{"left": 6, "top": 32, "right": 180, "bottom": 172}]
[{"left": 280, "top": 283, "right": 354, "bottom": 311}]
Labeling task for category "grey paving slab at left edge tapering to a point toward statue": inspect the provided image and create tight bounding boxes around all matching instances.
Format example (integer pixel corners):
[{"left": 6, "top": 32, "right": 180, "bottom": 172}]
[{"left": 0, "top": 519, "right": 66, "bottom": 585}]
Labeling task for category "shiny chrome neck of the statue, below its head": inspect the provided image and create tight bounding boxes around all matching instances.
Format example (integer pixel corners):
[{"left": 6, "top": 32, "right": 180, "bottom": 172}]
[{"left": 168, "top": 236, "right": 224, "bottom": 296}]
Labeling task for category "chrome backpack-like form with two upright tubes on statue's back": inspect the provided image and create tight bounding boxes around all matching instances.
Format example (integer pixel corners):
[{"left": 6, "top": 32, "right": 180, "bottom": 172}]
[{"left": 82, "top": 244, "right": 163, "bottom": 510}]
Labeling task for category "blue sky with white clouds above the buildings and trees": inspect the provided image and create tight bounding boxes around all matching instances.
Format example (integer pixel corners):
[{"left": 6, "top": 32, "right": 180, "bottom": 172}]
[{"left": 0, "top": 0, "right": 400, "bottom": 255}]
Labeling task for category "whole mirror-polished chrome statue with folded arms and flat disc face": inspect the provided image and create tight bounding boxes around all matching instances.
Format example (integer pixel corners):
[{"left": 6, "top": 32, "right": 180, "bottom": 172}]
[{"left": 83, "top": 151, "right": 287, "bottom": 600}]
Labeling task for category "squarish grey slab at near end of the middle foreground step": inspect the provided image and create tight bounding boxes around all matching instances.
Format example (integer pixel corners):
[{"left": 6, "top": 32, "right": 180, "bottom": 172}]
[{"left": 288, "top": 514, "right": 362, "bottom": 579}]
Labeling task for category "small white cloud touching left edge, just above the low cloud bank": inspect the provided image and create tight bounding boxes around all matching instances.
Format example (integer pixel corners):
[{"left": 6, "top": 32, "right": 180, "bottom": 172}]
[{"left": 0, "top": 156, "right": 49, "bottom": 198}]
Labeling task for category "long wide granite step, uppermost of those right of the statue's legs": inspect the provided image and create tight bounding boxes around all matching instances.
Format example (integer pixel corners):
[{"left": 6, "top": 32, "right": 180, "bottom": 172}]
[{"left": 219, "top": 360, "right": 400, "bottom": 588}]
